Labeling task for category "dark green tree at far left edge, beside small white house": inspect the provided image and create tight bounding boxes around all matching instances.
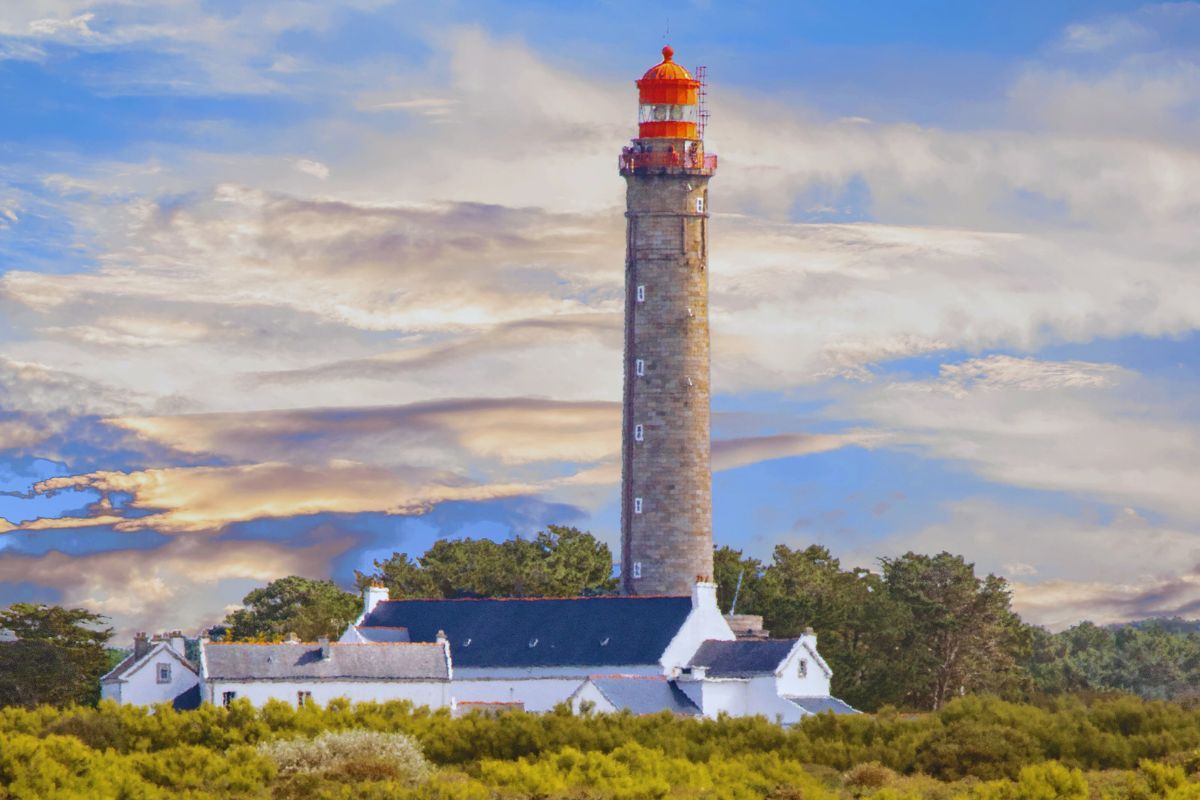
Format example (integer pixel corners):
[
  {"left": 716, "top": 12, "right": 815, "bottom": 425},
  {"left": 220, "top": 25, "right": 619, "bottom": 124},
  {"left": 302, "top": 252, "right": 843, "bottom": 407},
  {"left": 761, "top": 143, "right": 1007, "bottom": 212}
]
[{"left": 0, "top": 603, "right": 113, "bottom": 706}]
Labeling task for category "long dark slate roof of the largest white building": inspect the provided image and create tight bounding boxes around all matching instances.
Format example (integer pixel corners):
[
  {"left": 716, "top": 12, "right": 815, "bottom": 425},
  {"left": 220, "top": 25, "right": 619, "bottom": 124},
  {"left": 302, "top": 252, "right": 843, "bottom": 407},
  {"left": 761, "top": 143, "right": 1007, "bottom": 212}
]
[{"left": 359, "top": 597, "right": 691, "bottom": 667}]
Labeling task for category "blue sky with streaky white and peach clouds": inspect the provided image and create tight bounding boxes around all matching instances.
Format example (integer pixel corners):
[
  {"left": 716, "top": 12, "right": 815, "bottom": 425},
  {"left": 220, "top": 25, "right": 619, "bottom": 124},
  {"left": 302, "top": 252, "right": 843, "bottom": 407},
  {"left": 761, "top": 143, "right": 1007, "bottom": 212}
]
[{"left": 0, "top": 0, "right": 1200, "bottom": 636}]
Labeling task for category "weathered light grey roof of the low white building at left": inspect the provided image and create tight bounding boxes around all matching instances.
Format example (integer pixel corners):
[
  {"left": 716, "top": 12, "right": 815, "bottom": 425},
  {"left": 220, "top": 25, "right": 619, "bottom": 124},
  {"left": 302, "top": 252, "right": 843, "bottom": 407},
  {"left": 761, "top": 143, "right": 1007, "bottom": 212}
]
[{"left": 204, "top": 642, "right": 450, "bottom": 681}]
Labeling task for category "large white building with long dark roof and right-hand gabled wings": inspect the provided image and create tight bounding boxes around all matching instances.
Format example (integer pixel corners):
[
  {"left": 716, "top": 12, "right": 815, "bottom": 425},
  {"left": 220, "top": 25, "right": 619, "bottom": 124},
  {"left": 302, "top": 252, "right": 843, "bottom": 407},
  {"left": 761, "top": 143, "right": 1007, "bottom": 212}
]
[{"left": 342, "top": 582, "right": 853, "bottom": 724}]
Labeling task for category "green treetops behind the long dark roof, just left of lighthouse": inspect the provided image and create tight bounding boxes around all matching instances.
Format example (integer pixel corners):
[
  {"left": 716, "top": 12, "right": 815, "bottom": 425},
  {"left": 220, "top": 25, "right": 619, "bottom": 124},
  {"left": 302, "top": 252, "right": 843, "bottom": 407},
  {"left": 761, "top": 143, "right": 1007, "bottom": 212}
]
[{"left": 356, "top": 525, "right": 617, "bottom": 597}]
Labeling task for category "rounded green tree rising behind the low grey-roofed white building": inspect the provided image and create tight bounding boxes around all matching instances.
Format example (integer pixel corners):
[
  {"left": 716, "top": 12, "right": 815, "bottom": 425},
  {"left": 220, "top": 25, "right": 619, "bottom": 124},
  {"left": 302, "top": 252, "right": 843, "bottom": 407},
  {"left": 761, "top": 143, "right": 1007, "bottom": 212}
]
[{"left": 224, "top": 575, "right": 361, "bottom": 642}]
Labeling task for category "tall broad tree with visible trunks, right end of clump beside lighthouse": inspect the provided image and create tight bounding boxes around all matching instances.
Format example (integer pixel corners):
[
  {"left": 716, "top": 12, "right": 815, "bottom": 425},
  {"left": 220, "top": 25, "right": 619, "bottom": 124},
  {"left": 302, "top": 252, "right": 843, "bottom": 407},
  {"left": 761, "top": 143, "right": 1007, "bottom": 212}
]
[{"left": 881, "top": 552, "right": 1030, "bottom": 710}]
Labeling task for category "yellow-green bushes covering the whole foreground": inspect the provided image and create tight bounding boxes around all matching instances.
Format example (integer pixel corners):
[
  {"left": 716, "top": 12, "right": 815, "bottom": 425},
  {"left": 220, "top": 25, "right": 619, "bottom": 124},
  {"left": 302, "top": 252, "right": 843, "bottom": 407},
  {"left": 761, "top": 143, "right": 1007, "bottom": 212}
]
[{"left": 9, "top": 697, "right": 1200, "bottom": 800}]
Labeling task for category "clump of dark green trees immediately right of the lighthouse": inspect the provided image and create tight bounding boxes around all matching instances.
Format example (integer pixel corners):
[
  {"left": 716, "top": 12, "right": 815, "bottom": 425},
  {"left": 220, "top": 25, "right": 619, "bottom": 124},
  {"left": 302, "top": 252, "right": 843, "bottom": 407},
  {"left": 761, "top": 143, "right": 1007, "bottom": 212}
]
[{"left": 715, "top": 545, "right": 1034, "bottom": 709}]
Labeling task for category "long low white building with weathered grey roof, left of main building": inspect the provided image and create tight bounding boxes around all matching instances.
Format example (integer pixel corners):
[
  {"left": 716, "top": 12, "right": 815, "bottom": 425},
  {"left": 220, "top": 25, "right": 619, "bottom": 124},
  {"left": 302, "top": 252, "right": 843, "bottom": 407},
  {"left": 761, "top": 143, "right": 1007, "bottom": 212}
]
[{"left": 200, "top": 639, "right": 452, "bottom": 709}]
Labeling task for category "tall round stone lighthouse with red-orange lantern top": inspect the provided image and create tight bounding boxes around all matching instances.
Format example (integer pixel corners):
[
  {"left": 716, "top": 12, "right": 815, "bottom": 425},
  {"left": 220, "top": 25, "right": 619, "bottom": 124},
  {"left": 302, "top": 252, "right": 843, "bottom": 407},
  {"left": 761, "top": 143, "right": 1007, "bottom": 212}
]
[{"left": 619, "top": 47, "right": 716, "bottom": 595}]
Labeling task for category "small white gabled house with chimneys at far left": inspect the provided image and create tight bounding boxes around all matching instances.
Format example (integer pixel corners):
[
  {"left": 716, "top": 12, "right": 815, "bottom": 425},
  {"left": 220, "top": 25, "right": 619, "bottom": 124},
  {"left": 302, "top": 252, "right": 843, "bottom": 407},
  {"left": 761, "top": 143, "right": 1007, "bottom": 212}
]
[{"left": 100, "top": 632, "right": 200, "bottom": 709}]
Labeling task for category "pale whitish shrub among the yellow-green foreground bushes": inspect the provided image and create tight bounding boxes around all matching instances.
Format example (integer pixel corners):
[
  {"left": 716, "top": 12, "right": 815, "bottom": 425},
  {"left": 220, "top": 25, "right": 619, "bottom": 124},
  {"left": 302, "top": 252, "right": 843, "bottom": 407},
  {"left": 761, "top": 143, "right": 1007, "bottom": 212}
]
[{"left": 258, "top": 729, "right": 430, "bottom": 784}]
